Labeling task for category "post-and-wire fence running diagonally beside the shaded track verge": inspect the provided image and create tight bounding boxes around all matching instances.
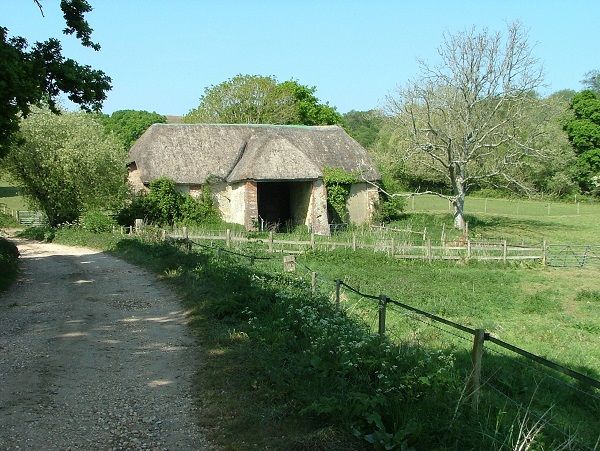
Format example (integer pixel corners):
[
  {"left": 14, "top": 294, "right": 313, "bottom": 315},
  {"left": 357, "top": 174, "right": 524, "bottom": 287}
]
[{"left": 137, "top": 230, "right": 600, "bottom": 450}]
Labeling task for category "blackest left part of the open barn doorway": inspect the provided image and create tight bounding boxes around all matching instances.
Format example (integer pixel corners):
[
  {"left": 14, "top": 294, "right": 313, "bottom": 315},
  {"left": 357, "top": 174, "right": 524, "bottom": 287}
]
[{"left": 257, "top": 182, "right": 292, "bottom": 229}]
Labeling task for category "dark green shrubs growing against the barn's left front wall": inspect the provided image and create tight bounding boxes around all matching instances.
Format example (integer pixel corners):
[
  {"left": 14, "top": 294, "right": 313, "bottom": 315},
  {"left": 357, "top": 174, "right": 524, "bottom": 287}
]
[{"left": 117, "top": 177, "right": 220, "bottom": 226}]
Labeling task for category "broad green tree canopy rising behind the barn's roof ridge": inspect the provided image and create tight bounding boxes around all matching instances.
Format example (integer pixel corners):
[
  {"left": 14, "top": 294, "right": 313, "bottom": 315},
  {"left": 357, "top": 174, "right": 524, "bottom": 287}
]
[{"left": 184, "top": 75, "right": 341, "bottom": 125}]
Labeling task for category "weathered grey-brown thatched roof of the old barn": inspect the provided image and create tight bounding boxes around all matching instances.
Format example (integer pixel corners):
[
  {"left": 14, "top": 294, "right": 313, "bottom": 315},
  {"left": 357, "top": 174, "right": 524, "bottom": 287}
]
[{"left": 129, "top": 124, "right": 380, "bottom": 184}]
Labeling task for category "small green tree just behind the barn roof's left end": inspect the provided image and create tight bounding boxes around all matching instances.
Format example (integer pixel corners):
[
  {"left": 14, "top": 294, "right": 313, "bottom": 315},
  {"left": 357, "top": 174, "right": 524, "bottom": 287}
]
[{"left": 102, "top": 110, "right": 167, "bottom": 151}]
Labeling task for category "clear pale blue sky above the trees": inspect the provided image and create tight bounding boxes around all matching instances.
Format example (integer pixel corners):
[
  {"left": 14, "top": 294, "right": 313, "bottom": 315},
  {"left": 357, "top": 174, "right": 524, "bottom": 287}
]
[{"left": 0, "top": 0, "right": 600, "bottom": 114}]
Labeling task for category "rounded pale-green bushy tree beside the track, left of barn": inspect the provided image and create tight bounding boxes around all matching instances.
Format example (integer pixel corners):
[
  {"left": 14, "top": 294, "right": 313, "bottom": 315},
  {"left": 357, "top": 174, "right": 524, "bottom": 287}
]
[{"left": 4, "top": 109, "right": 127, "bottom": 226}]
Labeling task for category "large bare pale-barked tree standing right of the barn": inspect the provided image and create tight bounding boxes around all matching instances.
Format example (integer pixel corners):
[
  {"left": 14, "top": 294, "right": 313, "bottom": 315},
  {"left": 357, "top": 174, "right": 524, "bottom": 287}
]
[{"left": 388, "top": 23, "right": 543, "bottom": 229}]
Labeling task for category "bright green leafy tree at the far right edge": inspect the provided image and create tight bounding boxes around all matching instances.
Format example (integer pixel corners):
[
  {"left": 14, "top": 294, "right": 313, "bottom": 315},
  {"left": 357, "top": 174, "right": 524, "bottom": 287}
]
[{"left": 565, "top": 90, "right": 600, "bottom": 192}]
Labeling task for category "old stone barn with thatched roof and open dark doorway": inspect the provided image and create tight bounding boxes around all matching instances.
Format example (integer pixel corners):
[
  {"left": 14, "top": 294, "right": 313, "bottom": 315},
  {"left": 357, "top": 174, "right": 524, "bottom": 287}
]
[{"left": 129, "top": 124, "right": 379, "bottom": 237}]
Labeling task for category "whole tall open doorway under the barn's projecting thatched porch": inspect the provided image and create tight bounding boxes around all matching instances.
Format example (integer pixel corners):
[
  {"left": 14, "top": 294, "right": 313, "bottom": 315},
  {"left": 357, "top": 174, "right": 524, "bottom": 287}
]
[{"left": 256, "top": 181, "right": 312, "bottom": 231}]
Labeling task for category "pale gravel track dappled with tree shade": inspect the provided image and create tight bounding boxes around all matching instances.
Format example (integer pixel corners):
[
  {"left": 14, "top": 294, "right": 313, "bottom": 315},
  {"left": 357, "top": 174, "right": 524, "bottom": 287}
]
[{"left": 0, "top": 241, "right": 211, "bottom": 450}]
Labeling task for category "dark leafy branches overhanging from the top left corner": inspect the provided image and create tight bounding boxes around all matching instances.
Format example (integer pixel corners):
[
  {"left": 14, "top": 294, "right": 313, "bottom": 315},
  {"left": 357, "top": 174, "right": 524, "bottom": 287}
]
[{"left": 0, "top": 0, "right": 111, "bottom": 157}]
